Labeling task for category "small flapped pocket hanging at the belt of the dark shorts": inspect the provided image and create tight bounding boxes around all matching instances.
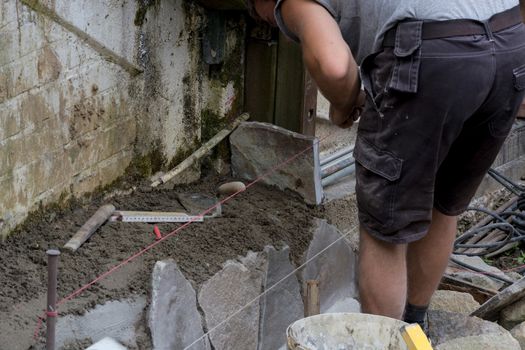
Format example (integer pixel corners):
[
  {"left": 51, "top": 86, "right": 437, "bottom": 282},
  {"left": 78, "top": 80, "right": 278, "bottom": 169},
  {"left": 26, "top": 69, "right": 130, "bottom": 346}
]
[{"left": 389, "top": 21, "right": 423, "bottom": 93}]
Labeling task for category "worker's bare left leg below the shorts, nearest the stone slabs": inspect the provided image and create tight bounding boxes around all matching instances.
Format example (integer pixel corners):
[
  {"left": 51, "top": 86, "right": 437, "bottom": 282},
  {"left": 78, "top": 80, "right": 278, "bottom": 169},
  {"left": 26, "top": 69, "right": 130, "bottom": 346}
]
[{"left": 359, "top": 228, "right": 407, "bottom": 319}]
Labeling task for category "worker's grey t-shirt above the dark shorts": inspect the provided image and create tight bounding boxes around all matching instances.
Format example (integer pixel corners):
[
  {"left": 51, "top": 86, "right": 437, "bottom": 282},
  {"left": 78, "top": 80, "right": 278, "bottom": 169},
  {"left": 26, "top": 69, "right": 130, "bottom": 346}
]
[{"left": 275, "top": 0, "right": 519, "bottom": 63}]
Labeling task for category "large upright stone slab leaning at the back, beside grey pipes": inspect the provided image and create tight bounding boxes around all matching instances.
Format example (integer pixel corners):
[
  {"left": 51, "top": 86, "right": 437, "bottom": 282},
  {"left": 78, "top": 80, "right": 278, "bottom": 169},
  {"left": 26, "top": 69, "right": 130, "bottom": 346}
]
[{"left": 230, "top": 122, "right": 323, "bottom": 204}]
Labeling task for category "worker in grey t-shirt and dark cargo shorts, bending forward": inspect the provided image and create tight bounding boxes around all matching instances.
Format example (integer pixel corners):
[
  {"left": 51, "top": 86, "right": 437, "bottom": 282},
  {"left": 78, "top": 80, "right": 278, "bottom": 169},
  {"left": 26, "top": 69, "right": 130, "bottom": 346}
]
[{"left": 248, "top": 0, "right": 525, "bottom": 326}]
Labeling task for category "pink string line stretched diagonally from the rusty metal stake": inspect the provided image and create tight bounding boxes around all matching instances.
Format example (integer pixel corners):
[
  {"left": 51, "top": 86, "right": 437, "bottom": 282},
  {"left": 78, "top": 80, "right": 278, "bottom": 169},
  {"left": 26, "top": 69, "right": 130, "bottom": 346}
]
[{"left": 33, "top": 133, "right": 333, "bottom": 339}]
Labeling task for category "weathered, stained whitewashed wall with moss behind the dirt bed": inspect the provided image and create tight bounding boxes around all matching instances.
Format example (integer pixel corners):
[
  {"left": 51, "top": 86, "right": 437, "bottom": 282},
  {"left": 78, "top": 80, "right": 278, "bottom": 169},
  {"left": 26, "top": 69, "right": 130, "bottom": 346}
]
[{"left": 0, "top": 0, "right": 245, "bottom": 236}]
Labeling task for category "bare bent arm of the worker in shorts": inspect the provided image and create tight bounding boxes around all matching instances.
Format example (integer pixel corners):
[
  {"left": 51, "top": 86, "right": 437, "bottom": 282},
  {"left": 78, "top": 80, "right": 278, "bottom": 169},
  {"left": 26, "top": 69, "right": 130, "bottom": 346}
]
[{"left": 282, "top": 0, "right": 363, "bottom": 127}]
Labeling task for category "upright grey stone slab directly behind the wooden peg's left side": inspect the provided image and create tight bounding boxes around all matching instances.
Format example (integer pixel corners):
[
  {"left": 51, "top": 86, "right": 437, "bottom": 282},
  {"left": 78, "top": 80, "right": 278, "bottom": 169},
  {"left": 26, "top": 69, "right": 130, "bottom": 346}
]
[{"left": 258, "top": 246, "right": 304, "bottom": 350}]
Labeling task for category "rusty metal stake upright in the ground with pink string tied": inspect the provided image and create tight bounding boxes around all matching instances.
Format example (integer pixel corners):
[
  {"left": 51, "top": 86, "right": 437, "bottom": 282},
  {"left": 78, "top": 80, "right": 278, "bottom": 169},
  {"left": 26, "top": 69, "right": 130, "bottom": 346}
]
[{"left": 46, "top": 249, "right": 60, "bottom": 350}]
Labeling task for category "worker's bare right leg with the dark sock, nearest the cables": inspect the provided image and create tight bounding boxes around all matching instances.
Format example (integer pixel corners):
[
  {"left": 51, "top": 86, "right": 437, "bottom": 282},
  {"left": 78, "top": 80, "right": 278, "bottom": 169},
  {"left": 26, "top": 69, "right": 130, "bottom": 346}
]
[{"left": 407, "top": 209, "right": 457, "bottom": 306}]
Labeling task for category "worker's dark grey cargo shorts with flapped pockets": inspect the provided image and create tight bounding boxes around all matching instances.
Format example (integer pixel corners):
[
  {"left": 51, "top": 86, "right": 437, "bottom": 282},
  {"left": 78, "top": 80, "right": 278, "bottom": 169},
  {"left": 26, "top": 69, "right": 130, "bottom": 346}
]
[{"left": 354, "top": 8, "right": 525, "bottom": 243}]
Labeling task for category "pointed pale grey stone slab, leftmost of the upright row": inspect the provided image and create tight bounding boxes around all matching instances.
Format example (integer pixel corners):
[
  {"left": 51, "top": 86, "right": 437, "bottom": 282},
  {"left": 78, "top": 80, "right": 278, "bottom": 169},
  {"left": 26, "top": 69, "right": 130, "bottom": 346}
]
[{"left": 148, "top": 259, "right": 209, "bottom": 350}]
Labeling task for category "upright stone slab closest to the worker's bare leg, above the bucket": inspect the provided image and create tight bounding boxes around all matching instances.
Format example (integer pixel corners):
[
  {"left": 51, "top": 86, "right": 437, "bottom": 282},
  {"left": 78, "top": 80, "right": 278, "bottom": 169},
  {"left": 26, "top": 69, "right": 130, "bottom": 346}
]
[{"left": 303, "top": 219, "right": 357, "bottom": 313}]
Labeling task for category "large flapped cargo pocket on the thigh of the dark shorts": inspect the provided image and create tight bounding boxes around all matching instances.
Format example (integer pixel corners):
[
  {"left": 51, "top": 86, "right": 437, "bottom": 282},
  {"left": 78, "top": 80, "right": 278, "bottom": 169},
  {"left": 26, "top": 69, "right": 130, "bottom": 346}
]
[{"left": 354, "top": 137, "right": 403, "bottom": 231}]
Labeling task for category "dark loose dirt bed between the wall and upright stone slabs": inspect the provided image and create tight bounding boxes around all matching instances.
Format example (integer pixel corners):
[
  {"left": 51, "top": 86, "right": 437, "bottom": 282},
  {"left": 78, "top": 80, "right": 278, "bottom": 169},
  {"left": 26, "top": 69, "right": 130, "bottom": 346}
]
[{"left": 0, "top": 177, "right": 322, "bottom": 350}]
